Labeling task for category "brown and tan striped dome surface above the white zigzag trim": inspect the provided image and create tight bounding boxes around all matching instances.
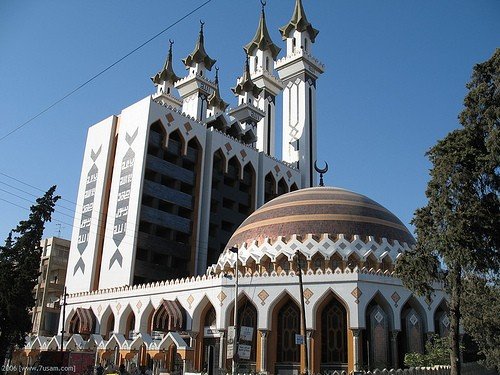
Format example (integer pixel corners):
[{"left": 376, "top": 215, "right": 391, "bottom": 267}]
[{"left": 227, "top": 187, "right": 415, "bottom": 247}]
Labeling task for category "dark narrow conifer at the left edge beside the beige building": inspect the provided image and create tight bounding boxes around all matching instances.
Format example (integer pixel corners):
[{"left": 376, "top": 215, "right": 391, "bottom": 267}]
[{"left": 0, "top": 186, "right": 60, "bottom": 363}]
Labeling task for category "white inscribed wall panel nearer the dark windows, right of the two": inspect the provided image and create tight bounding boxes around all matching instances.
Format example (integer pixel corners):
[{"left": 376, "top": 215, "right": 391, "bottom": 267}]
[{"left": 99, "top": 97, "right": 151, "bottom": 289}]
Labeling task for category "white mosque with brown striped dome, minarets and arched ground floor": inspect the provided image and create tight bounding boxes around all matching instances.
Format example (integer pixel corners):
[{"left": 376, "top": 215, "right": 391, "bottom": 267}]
[{"left": 23, "top": 0, "right": 449, "bottom": 375}]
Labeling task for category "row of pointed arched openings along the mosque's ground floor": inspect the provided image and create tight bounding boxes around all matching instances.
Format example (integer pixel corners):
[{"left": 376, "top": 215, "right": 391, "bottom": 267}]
[{"left": 62, "top": 291, "right": 449, "bottom": 374}]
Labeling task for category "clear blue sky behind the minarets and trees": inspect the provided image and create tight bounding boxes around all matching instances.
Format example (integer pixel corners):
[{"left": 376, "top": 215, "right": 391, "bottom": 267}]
[{"left": 0, "top": 0, "right": 500, "bottom": 241}]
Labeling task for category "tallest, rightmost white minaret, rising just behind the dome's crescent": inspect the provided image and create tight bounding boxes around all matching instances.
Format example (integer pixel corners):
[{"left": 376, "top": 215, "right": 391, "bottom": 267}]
[{"left": 275, "top": 0, "right": 324, "bottom": 188}]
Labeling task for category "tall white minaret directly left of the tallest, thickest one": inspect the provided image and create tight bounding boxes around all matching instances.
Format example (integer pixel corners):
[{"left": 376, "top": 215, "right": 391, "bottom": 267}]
[{"left": 244, "top": 1, "right": 283, "bottom": 156}]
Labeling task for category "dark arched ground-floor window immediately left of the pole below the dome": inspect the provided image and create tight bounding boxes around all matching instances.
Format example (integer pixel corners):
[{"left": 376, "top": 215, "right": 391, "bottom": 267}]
[{"left": 277, "top": 301, "right": 300, "bottom": 362}]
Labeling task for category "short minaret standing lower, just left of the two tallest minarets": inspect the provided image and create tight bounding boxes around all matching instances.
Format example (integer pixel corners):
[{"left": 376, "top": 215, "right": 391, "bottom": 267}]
[{"left": 229, "top": 55, "right": 264, "bottom": 147}]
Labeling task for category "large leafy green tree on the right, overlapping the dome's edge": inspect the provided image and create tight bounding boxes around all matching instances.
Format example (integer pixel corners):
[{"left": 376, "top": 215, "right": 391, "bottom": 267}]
[{"left": 396, "top": 49, "right": 500, "bottom": 375}]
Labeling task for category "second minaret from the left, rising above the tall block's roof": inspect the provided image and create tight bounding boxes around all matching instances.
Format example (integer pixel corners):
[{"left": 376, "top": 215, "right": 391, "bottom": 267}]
[{"left": 175, "top": 21, "right": 215, "bottom": 121}]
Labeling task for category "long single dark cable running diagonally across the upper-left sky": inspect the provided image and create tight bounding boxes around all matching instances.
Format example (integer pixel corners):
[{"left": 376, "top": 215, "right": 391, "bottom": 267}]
[{"left": 0, "top": 0, "right": 212, "bottom": 142}]
